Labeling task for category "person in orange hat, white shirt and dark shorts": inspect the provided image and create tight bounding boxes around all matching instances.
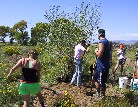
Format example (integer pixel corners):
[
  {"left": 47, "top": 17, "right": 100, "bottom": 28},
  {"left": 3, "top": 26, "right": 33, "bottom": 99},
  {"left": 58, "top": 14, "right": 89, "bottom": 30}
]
[{"left": 112, "top": 44, "right": 126, "bottom": 79}]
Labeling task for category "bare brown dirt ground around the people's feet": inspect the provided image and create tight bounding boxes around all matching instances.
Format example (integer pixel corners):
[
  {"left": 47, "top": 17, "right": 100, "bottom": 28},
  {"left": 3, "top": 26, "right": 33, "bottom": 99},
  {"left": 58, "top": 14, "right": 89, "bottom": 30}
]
[{"left": 35, "top": 82, "right": 123, "bottom": 107}]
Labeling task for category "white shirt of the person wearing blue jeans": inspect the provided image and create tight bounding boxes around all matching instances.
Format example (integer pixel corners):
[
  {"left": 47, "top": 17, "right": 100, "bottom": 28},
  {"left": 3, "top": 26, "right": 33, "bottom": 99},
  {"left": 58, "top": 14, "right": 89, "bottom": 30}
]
[{"left": 74, "top": 44, "right": 86, "bottom": 59}]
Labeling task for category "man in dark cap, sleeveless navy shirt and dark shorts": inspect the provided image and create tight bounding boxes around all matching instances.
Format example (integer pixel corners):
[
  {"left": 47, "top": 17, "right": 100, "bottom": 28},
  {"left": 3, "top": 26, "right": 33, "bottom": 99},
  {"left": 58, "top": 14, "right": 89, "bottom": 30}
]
[{"left": 94, "top": 29, "right": 111, "bottom": 98}]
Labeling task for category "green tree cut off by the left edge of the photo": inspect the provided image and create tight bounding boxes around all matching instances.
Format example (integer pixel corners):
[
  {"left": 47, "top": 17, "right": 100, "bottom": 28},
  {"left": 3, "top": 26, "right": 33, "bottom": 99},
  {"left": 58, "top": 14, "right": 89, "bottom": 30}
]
[{"left": 0, "top": 26, "right": 9, "bottom": 43}]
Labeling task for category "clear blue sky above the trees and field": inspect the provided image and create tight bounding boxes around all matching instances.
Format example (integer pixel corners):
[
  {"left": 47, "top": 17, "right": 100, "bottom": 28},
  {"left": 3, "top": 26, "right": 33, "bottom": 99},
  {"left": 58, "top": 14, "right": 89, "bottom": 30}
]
[{"left": 0, "top": 0, "right": 138, "bottom": 41}]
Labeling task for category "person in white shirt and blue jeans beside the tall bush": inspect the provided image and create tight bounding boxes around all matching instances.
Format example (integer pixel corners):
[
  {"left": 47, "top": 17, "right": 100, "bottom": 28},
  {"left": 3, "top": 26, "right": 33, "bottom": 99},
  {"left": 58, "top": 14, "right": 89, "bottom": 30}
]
[{"left": 70, "top": 40, "right": 89, "bottom": 86}]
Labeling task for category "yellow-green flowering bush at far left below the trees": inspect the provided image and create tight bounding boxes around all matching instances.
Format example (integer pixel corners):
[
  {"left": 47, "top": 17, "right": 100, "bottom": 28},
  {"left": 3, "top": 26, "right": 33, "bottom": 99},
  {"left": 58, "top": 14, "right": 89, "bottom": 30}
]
[{"left": 3, "top": 46, "right": 20, "bottom": 56}]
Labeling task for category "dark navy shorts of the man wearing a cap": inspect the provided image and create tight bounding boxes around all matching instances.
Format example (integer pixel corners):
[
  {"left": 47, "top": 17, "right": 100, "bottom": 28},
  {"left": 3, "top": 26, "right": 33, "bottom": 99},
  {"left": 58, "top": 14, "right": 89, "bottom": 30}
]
[{"left": 94, "top": 70, "right": 109, "bottom": 87}]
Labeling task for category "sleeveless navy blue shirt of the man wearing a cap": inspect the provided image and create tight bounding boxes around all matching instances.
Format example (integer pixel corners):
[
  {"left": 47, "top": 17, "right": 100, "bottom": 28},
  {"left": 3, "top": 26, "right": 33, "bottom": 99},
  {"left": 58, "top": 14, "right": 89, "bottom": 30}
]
[{"left": 96, "top": 39, "right": 110, "bottom": 71}]
